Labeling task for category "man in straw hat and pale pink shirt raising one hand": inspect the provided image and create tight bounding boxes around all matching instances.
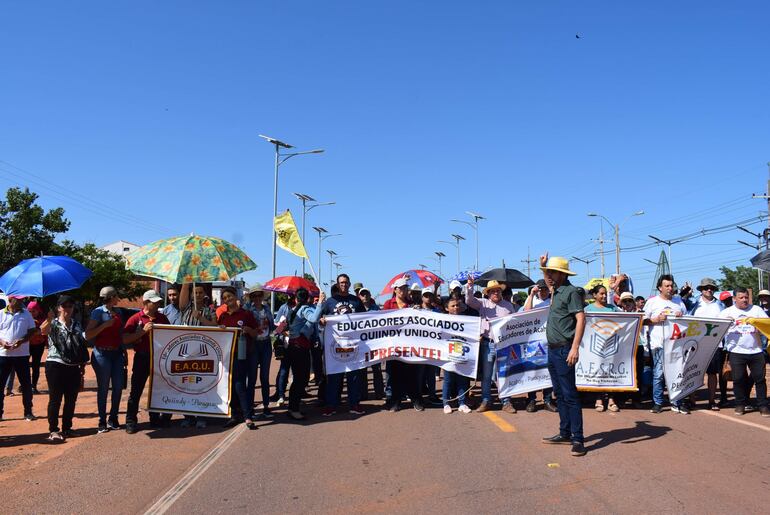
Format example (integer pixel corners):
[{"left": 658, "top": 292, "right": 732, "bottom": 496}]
[{"left": 465, "top": 274, "right": 516, "bottom": 413}]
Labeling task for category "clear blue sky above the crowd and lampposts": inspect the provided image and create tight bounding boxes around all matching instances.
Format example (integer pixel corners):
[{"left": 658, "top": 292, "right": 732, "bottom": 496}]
[{"left": 0, "top": 1, "right": 770, "bottom": 294}]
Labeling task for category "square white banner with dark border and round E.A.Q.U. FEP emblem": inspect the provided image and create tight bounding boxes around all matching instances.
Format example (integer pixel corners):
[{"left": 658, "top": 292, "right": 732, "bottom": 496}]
[{"left": 147, "top": 325, "right": 238, "bottom": 417}]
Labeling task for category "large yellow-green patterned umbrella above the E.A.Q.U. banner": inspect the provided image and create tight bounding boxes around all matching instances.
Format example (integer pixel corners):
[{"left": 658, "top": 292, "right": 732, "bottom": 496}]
[{"left": 126, "top": 234, "right": 257, "bottom": 284}]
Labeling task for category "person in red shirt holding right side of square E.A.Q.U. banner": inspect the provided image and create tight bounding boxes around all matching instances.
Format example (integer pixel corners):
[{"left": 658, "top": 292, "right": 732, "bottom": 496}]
[{"left": 217, "top": 286, "right": 259, "bottom": 429}]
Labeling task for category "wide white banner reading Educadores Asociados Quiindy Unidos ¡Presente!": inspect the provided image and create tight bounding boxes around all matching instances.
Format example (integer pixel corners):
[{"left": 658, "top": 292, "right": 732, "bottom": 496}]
[{"left": 324, "top": 308, "right": 481, "bottom": 378}]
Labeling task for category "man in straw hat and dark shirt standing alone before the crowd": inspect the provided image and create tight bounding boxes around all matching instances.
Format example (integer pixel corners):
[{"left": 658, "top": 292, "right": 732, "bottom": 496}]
[{"left": 540, "top": 252, "right": 586, "bottom": 456}]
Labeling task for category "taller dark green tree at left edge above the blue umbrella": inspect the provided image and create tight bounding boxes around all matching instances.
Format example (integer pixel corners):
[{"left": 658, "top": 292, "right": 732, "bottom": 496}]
[{"left": 0, "top": 188, "right": 70, "bottom": 273}]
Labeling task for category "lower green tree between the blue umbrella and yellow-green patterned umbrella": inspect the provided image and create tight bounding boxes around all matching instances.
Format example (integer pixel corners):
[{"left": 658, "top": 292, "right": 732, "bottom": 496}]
[{"left": 56, "top": 240, "right": 145, "bottom": 304}]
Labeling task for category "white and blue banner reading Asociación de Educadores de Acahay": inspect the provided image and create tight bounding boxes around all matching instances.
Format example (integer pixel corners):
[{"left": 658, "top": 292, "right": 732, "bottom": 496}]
[{"left": 482, "top": 308, "right": 551, "bottom": 399}]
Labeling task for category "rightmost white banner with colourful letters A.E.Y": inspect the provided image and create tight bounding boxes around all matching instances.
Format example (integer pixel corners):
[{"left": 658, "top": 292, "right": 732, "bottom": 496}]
[{"left": 663, "top": 317, "right": 731, "bottom": 402}]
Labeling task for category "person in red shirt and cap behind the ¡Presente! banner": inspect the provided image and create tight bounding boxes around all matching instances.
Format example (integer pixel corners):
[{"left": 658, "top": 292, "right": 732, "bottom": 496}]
[{"left": 382, "top": 277, "right": 425, "bottom": 412}]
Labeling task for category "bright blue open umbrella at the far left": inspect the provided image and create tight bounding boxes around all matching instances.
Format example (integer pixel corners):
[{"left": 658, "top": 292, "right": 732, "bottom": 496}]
[{"left": 0, "top": 256, "right": 92, "bottom": 297}]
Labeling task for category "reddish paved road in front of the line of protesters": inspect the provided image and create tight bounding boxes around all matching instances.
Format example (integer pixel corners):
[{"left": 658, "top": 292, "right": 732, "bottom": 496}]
[{"left": 3, "top": 372, "right": 770, "bottom": 514}]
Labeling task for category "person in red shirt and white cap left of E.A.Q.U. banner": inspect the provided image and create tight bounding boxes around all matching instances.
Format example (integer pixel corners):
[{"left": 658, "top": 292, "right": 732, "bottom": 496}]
[{"left": 123, "top": 290, "right": 171, "bottom": 434}]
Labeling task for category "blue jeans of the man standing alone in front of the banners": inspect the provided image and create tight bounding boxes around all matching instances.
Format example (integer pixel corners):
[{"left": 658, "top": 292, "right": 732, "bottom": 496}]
[{"left": 548, "top": 344, "right": 583, "bottom": 443}]
